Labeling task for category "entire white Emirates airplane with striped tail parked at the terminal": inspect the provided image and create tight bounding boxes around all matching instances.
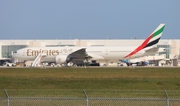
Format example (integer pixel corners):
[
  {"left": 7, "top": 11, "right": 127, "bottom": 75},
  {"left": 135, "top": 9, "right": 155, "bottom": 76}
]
[{"left": 13, "top": 24, "right": 165, "bottom": 64}]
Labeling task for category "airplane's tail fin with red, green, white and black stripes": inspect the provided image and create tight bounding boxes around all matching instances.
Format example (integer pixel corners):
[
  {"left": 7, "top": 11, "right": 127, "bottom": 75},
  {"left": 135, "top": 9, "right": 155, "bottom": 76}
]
[{"left": 124, "top": 24, "right": 165, "bottom": 58}]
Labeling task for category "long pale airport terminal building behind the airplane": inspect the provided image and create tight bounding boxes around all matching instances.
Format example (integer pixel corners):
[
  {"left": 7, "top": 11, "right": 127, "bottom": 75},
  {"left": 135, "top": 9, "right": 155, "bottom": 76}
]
[{"left": 0, "top": 39, "right": 180, "bottom": 65}]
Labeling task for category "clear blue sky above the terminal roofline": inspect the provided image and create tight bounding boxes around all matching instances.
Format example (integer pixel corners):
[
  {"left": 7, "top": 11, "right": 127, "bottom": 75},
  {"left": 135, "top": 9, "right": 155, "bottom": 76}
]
[{"left": 0, "top": 0, "right": 180, "bottom": 39}]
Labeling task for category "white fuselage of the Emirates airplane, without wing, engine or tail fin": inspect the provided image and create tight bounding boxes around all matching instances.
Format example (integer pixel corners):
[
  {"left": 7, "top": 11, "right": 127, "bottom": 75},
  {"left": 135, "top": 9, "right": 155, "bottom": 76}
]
[{"left": 13, "top": 46, "right": 144, "bottom": 62}]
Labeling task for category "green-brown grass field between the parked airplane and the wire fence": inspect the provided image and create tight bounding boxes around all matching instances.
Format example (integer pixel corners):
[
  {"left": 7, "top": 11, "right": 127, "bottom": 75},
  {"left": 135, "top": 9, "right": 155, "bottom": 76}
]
[{"left": 0, "top": 68, "right": 180, "bottom": 96}]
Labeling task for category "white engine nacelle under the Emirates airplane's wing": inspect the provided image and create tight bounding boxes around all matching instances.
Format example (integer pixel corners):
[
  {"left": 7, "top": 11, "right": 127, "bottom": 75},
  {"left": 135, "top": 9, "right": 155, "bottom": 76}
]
[{"left": 55, "top": 55, "right": 69, "bottom": 64}]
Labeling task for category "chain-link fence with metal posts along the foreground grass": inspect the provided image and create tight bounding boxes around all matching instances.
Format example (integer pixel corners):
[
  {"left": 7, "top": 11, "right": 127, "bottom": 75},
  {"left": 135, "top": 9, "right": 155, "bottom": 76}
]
[{"left": 0, "top": 90, "right": 180, "bottom": 106}]
